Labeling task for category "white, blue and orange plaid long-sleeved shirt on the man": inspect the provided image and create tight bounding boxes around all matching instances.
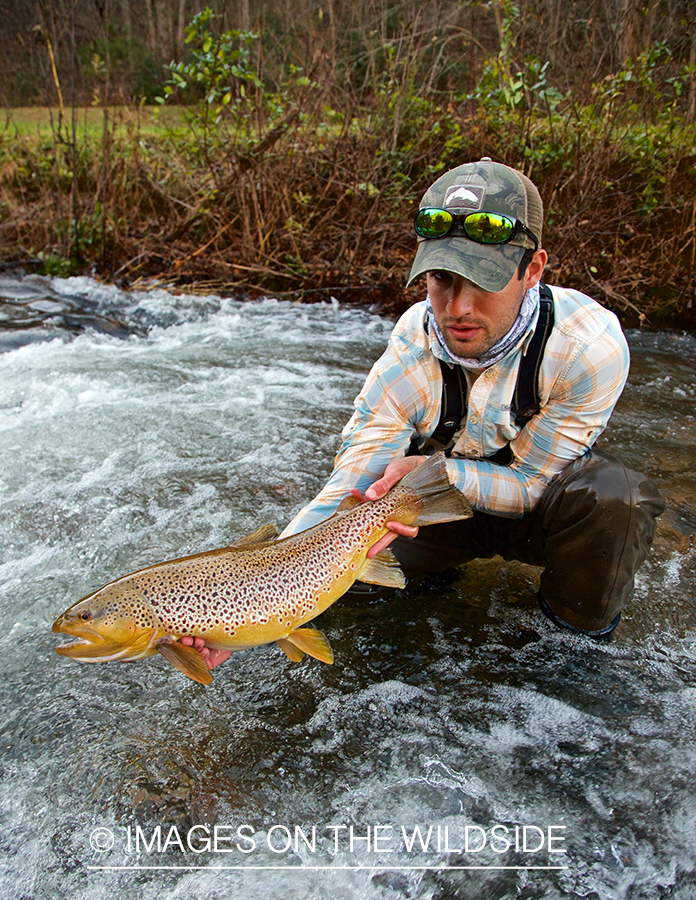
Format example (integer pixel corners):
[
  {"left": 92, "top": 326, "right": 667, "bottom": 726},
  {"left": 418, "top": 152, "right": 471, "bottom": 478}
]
[{"left": 284, "top": 287, "right": 629, "bottom": 535}]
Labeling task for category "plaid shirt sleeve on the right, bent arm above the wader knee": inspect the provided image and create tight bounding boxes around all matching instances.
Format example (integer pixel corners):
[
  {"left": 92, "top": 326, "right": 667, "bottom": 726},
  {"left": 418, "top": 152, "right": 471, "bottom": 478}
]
[{"left": 447, "top": 324, "right": 629, "bottom": 518}]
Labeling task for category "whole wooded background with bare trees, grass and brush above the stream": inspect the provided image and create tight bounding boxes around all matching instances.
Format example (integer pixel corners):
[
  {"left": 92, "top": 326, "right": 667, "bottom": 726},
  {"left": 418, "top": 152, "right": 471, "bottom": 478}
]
[{"left": 0, "top": 0, "right": 696, "bottom": 327}]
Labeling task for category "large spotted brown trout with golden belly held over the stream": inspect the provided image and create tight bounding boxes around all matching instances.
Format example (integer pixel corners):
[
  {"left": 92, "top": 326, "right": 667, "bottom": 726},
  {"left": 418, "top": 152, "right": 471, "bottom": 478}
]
[{"left": 53, "top": 453, "right": 471, "bottom": 684}]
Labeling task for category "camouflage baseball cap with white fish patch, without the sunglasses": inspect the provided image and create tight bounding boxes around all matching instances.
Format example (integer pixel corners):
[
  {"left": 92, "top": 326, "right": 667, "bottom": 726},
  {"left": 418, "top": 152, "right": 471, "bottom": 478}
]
[{"left": 408, "top": 157, "right": 544, "bottom": 293}]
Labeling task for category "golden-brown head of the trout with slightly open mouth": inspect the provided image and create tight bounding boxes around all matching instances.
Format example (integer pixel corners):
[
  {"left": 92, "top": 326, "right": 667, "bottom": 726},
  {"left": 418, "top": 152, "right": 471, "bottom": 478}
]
[{"left": 52, "top": 582, "right": 159, "bottom": 662}]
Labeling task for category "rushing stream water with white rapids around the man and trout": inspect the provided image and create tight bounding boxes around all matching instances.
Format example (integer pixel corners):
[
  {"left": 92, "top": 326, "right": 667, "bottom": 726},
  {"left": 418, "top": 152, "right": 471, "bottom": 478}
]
[{"left": 0, "top": 277, "right": 696, "bottom": 900}]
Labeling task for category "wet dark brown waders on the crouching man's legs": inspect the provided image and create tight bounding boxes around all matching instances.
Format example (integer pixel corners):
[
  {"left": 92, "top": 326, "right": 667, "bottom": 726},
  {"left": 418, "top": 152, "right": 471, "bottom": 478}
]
[{"left": 391, "top": 449, "right": 665, "bottom": 637}]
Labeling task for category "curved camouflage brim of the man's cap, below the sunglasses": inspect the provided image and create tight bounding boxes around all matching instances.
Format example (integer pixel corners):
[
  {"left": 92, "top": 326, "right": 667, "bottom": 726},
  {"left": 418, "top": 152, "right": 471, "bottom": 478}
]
[{"left": 407, "top": 237, "right": 526, "bottom": 293}]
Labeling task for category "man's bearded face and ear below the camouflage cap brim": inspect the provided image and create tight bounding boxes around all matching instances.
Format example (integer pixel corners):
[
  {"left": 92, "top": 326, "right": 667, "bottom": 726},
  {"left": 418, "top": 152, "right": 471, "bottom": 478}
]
[{"left": 427, "top": 250, "right": 546, "bottom": 359}]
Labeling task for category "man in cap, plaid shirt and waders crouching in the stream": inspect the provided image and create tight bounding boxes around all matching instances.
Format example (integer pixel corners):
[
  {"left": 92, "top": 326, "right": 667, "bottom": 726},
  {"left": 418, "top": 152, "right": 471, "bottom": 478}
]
[{"left": 188, "top": 158, "right": 664, "bottom": 662}]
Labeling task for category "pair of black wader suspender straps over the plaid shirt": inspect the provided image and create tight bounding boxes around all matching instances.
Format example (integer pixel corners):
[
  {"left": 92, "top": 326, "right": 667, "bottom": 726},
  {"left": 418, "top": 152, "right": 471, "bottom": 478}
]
[{"left": 406, "top": 284, "right": 554, "bottom": 465}]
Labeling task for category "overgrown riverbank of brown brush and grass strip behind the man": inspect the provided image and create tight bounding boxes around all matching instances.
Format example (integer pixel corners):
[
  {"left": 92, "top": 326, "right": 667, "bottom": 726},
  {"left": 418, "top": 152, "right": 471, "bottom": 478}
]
[{"left": 0, "top": 74, "right": 696, "bottom": 328}]
